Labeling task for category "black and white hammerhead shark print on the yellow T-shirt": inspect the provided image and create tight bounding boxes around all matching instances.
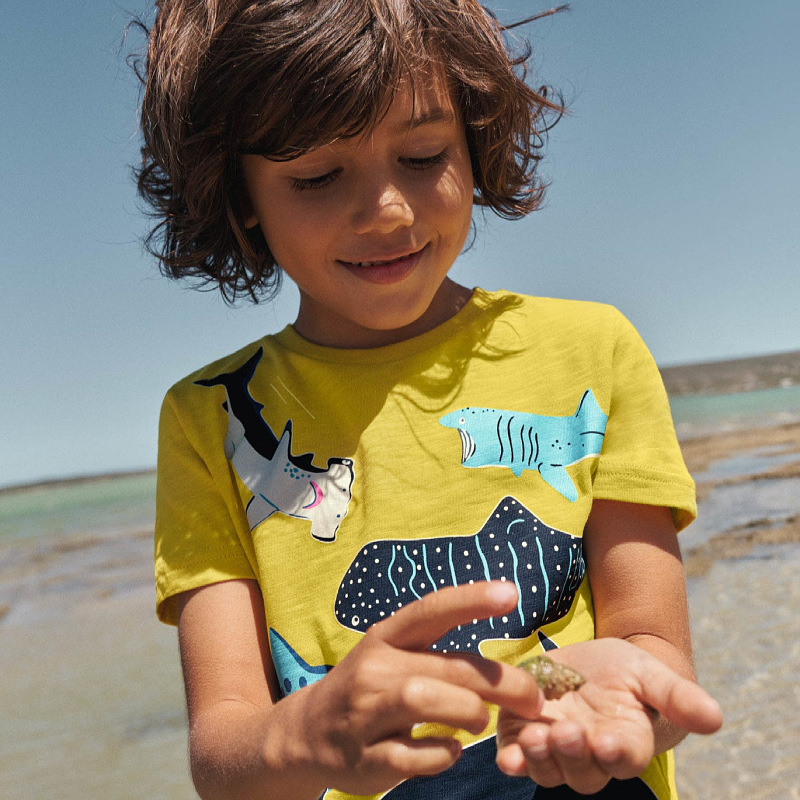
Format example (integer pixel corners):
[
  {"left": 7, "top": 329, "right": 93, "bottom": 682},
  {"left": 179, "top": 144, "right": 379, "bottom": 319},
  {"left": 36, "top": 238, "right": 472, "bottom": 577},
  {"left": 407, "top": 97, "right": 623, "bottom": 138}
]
[{"left": 195, "top": 348, "right": 354, "bottom": 542}]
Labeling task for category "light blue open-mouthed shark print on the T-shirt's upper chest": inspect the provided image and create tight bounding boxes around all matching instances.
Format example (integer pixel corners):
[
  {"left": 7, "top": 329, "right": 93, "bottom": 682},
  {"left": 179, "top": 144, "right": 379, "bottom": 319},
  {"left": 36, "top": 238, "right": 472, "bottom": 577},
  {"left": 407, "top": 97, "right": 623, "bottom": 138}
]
[{"left": 439, "top": 389, "right": 608, "bottom": 503}]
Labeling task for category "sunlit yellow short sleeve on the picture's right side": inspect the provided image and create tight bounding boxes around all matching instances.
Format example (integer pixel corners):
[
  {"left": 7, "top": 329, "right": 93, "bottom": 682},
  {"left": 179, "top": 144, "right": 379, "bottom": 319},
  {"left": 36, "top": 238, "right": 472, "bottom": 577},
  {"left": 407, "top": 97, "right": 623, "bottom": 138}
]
[{"left": 593, "top": 312, "right": 697, "bottom": 530}]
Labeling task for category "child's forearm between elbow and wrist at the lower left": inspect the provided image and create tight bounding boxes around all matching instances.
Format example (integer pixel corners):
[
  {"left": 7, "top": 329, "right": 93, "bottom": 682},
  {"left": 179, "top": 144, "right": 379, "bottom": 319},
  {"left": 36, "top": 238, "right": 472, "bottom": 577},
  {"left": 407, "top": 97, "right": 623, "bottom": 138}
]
[{"left": 189, "top": 693, "right": 327, "bottom": 800}]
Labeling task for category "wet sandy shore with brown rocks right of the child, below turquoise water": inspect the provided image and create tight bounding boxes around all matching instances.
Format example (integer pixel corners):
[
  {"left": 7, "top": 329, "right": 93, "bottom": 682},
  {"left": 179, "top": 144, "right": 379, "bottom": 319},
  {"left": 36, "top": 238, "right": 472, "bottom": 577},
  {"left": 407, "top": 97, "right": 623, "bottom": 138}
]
[{"left": 677, "top": 425, "right": 800, "bottom": 800}]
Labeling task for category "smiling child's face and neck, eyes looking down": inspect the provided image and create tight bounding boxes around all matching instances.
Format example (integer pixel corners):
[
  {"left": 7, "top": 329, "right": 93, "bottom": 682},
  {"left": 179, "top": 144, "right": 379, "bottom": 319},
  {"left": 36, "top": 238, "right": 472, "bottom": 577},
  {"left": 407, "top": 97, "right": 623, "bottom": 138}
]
[{"left": 242, "top": 76, "right": 473, "bottom": 347}]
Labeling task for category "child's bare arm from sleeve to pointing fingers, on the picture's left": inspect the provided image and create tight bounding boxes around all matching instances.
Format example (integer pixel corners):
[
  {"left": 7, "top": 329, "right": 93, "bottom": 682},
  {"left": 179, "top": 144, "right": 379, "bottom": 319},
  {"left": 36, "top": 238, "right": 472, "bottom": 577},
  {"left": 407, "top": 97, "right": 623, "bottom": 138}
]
[{"left": 178, "top": 580, "right": 542, "bottom": 800}]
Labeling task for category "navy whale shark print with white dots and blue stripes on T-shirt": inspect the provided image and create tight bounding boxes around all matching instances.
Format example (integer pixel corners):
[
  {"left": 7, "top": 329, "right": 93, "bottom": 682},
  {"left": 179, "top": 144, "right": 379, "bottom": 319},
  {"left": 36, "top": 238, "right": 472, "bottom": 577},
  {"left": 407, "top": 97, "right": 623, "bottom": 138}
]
[{"left": 335, "top": 497, "right": 586, "bottom": 652}]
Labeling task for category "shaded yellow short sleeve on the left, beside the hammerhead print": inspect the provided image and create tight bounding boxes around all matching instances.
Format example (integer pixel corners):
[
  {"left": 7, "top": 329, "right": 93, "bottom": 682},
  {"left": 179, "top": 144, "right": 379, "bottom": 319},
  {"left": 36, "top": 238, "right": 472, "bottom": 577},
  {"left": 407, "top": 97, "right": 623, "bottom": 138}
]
[{"left": 155, "top": 392, "right": 255, "bottom": 625}]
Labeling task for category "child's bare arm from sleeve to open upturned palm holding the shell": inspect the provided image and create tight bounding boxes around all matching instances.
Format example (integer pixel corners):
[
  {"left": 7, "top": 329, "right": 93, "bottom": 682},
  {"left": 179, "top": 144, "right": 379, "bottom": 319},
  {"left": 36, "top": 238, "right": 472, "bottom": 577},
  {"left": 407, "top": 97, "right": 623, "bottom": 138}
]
[{"left": 498, "top": 500, "right": 722, "bottom": 793}]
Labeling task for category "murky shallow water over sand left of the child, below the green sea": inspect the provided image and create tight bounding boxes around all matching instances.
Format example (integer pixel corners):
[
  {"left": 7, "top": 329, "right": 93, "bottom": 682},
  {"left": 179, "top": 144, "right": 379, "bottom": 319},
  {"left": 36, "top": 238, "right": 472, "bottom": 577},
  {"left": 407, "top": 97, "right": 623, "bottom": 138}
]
[{"left": 0, "top": 532, "right": 191, "bottom": 800}]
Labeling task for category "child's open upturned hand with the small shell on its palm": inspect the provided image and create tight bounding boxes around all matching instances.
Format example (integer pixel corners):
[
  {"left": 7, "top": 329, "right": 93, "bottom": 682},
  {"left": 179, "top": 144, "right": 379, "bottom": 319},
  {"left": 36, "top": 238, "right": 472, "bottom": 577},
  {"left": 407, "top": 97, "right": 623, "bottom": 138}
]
[{"left": 497, "top": 638, "right": 722, "bottom": 794}]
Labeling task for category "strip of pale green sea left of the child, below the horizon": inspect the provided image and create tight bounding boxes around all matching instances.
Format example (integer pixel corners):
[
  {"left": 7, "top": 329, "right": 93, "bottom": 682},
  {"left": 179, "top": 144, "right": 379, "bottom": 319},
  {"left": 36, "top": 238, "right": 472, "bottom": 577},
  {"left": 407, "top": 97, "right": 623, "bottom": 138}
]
[{"left": 0, "top": 473, "right": 156, "bottom": 541}]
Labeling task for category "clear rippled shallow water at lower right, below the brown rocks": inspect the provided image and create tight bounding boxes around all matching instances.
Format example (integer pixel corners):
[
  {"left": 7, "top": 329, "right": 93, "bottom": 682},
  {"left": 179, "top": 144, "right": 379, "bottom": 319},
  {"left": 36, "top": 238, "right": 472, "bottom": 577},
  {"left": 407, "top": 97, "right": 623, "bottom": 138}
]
[{"left": 677, "top": 544, "right": 800, "bottom": 800}]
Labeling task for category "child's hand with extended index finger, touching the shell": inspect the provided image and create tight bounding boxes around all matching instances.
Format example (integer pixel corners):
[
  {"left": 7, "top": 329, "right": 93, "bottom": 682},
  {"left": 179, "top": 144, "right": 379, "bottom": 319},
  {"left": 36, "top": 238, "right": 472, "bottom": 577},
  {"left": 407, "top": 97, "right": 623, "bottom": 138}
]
[{"left": 287, "top": 581, "right": 543, "bottom": 795}]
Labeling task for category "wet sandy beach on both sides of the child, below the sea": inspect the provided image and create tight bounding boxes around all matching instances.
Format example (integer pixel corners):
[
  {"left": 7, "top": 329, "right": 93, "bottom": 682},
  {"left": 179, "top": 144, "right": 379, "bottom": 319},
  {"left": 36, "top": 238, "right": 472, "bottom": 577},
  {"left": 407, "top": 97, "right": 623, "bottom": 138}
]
[{"left": 0, "top": 418, "right": 800, "bottom": 800}]
